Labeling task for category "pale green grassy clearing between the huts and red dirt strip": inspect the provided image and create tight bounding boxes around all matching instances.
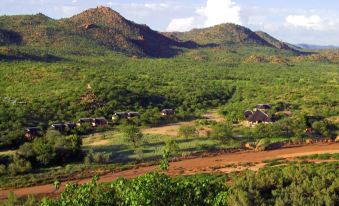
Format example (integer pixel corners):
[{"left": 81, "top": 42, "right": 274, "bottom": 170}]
[{"left": 83, "top": 131, "right": 233, "bottom": 162}]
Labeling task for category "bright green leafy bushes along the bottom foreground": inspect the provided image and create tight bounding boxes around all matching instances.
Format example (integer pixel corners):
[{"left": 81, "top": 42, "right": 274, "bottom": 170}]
[{"left": 32, "top": 162, "right": 339, "bottom": 206}]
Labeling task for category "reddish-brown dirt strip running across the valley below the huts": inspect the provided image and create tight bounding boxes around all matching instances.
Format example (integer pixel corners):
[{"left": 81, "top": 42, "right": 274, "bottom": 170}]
[{"left": 0, "top": 143, "right": 339, "bottom": 200}]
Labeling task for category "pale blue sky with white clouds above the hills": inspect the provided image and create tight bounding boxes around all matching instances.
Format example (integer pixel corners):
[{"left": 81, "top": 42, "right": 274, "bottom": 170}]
[{"left": 0, "top": 0, "right": 339, "bottom": 46}]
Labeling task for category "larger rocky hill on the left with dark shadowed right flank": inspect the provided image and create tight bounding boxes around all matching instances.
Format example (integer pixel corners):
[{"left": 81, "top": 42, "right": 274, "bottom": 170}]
[{"left": 0, "top": 7, "right": 195, "bottom": 57}]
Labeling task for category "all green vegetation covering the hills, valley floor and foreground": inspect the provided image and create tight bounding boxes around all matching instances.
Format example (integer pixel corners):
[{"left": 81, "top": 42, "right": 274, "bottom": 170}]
[{"left": 0, "top": 7, "right": 339, "bottom": 205}]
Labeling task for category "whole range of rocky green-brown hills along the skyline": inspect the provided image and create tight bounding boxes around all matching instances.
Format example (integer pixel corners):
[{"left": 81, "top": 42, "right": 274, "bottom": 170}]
[{"left": 0, "top": 6, "right": 298, "bottom": 57}]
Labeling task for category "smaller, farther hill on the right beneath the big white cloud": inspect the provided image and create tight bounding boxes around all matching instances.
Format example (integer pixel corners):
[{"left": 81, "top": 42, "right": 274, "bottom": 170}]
[{"left": 164, "top": 23, "right": 302, "bottom": 50}]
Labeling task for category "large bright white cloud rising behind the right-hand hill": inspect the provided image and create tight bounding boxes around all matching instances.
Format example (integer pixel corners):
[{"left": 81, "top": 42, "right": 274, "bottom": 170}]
[{"left": 167, "top": 0, "right": 241, "bottom": 31}]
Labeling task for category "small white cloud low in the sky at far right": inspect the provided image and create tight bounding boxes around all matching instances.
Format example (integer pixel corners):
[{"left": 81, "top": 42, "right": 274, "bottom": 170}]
[{"left": 285, "top": 15, "right": 324, "bottom": 30}]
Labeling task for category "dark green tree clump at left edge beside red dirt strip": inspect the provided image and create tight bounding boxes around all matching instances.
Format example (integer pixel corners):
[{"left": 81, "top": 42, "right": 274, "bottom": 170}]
[{"left": 0, "top": 130, "right": 84, "bottom": 175}]
